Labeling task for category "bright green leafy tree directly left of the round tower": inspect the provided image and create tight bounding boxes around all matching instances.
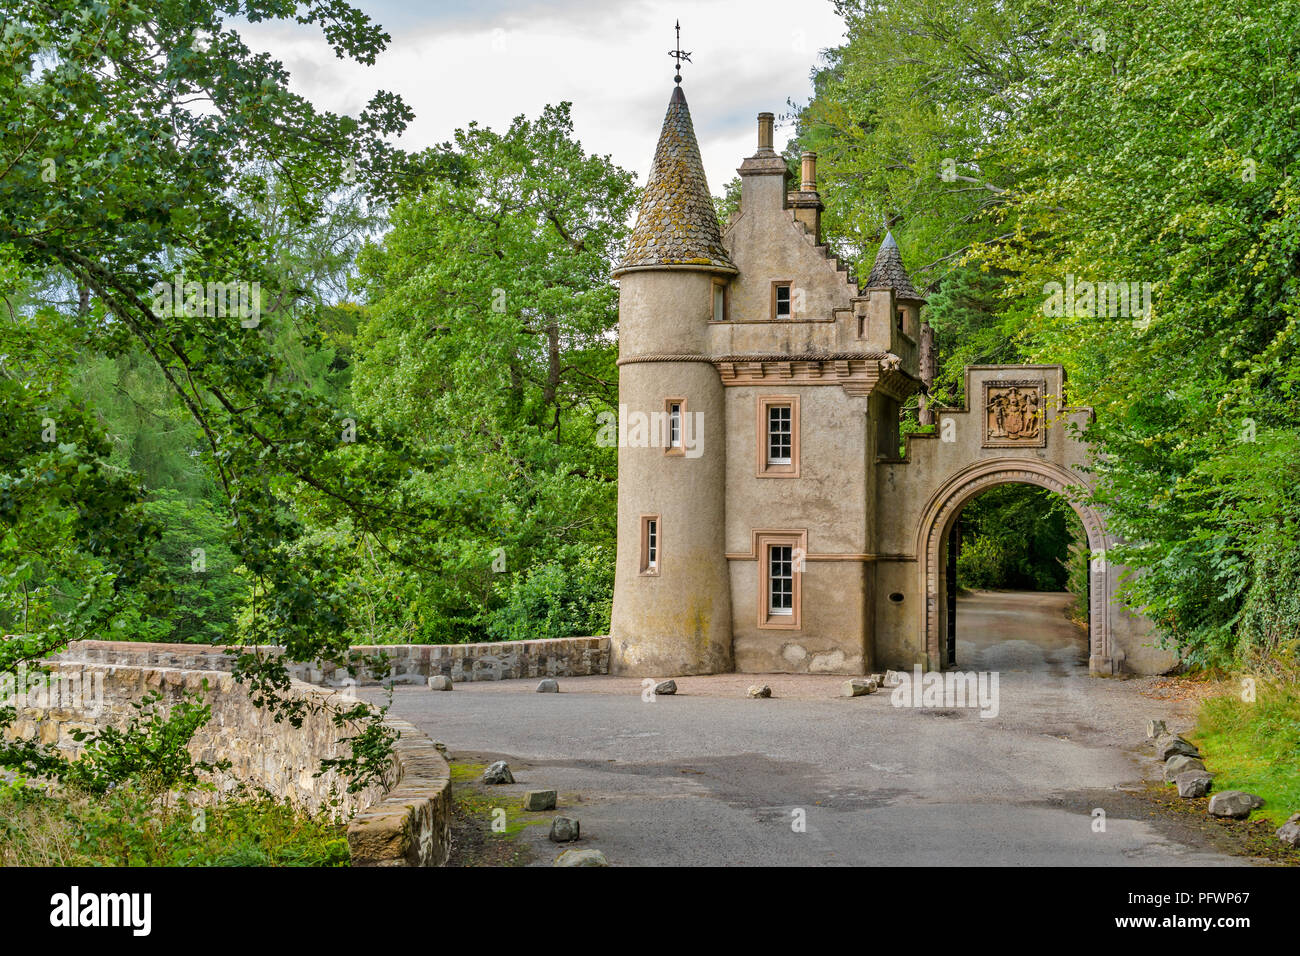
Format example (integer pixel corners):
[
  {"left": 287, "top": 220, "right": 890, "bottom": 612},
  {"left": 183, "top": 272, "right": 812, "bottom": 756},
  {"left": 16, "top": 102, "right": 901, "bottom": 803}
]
[{"left": 338, "top": 104, "right": 634, "bottom": 643}]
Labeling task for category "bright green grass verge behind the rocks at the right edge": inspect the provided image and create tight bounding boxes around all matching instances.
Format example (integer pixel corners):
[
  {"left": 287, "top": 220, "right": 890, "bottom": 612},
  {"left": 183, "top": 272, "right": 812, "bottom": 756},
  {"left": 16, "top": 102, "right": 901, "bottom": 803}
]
[{"left": 1193, "top": 678, "right": 1300, "bottom": 826}]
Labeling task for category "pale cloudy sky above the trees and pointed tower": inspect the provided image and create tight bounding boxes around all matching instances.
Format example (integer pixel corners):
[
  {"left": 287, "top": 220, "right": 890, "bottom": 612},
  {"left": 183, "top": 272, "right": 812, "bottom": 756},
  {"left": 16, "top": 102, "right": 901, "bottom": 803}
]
[{"left": 237, "top": 0, "right": 844, "bottom": 194}]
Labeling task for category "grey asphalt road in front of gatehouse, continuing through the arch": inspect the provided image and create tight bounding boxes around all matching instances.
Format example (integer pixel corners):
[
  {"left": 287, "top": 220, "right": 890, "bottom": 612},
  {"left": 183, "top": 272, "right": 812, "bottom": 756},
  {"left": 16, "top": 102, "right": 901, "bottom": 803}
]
[{"left": 371, "top": 593, "right": 1245, "bottom": 866}]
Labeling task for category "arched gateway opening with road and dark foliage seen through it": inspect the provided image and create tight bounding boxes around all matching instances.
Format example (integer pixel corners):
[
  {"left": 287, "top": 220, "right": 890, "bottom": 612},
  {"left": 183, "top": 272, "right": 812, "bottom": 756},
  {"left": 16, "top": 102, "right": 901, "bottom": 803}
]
[{"left": 939, "top": 481, "right": 1091, "bottom": 676}]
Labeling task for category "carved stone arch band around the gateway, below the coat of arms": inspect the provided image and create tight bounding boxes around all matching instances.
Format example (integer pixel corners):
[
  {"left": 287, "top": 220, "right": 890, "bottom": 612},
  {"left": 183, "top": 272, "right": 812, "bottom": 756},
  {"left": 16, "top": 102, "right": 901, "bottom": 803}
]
[{"left": 917, "top": 458, "right": 1114, "bottom": 674}]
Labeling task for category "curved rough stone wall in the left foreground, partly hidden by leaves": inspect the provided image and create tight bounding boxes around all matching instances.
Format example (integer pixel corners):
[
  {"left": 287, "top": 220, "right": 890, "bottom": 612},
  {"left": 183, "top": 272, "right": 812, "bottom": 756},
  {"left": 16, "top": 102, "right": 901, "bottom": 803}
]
[{"left": 7, "top": 658, "right": 451, "bottom": 866}]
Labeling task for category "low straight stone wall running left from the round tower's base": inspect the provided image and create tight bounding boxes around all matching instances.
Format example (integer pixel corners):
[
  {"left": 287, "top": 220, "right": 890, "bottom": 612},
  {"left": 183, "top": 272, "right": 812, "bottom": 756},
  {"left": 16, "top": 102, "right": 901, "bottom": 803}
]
[{"left": 60, "top": 637, "right": 610, "bottom": 684}]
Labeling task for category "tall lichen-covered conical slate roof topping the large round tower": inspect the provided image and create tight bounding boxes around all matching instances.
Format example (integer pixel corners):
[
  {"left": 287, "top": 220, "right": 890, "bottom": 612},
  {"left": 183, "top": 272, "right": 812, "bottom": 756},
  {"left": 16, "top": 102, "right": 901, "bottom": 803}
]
[{"left": 614, "top": 86, "right": 736, "bottom": 276}]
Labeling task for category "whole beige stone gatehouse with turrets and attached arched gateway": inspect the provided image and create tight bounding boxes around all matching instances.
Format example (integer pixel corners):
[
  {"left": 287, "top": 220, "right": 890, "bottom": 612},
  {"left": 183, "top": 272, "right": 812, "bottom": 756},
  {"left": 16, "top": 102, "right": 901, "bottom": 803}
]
[{"left": 610, "top": 86, "right": 1173, "bottom": 675}]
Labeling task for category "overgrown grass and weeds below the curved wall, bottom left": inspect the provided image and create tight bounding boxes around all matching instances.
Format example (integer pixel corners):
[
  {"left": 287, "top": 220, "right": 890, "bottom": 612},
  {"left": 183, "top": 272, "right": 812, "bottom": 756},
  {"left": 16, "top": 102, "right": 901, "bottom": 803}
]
[{"left": 0, "top": 780, "right": 350, "bottom": 866}]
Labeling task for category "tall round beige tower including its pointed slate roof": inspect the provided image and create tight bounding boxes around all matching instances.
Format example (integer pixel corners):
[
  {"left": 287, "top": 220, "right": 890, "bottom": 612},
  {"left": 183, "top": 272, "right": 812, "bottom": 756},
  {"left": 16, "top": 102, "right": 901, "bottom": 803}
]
[{"left": 610, "top": 85, "right": 737, "bottom": 676}]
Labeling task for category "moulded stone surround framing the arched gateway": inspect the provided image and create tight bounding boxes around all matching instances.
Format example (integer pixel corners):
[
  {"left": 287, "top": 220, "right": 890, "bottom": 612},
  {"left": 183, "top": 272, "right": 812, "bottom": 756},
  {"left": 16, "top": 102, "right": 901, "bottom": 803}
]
[{"left": 917, "top": 459, "right": 1110, "bottom": 672}]
